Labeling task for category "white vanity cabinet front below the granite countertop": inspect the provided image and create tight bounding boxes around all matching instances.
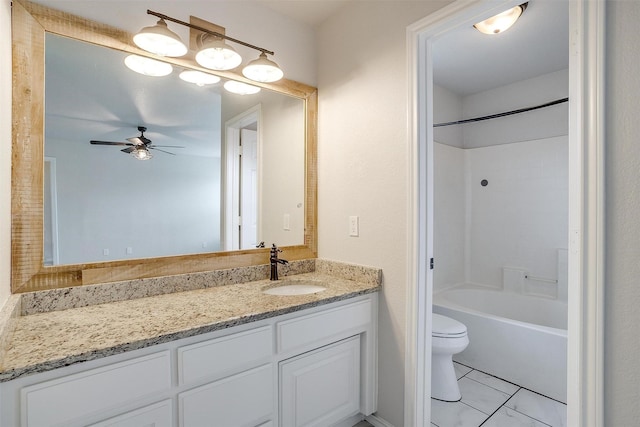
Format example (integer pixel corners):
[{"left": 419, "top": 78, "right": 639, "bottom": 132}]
[{"left": 0, "top": 293, "right": 377, "bottom": 427}]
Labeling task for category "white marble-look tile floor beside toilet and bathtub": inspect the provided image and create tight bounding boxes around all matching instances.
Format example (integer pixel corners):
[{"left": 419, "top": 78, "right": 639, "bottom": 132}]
[{"left": 431, "top": 363, "right": 567, "bottom": 427}]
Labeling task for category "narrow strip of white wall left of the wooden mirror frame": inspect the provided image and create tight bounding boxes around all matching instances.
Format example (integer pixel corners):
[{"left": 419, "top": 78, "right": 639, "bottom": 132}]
[{"left": 0, "top": 0, "right": 12, "bottom": 308}]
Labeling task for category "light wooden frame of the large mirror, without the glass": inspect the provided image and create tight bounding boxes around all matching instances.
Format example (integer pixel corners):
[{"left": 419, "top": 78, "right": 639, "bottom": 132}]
[{"left": 11, "top": 1, "right": 317, "bottom": 293}]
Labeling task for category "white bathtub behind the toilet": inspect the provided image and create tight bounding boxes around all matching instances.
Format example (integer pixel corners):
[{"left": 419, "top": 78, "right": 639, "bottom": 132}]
[{"left": 433, "top": 285, "right": 567, "bottom": 403}]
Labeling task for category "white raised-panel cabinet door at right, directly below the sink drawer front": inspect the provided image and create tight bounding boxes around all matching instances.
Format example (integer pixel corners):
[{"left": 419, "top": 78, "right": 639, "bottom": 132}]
[{"left": 279, "top": 335, "right": 360, "bottom": 427}]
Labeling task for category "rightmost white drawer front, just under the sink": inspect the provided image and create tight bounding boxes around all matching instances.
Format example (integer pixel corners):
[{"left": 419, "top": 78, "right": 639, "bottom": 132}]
[{"left": 277, "top": 300, "right": 371, "bottom": 352}]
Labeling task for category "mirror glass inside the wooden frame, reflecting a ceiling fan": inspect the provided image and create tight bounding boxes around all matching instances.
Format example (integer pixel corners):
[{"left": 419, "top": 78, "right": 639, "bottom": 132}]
[{"left": 44, "top": 34, "right": 305, "bottom": 265}]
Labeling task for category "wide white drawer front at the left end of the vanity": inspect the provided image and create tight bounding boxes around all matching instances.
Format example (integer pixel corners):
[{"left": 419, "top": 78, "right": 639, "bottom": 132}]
[{"left": 21, "top": 351, "right": 171, "bottom": 427}]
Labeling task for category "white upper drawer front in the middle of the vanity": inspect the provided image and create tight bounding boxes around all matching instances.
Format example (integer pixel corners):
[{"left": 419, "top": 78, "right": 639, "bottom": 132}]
[{"left": 178, "top": 326, "right": 273, "bottom": 385}]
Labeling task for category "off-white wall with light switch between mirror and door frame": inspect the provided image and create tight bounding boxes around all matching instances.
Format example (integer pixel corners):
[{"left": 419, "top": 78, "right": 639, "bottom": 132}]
[{"left": 318, "top": 1, "right": 448, "bottom": 427}]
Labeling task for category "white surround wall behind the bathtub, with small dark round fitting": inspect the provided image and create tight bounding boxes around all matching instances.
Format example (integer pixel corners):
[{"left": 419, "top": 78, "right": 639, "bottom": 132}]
[{"left": 468, "top": 137, "right": 569, "bottom": 295}]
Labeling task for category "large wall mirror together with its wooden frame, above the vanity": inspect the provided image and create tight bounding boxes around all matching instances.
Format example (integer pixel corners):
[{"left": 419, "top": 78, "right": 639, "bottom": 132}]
[{"left": 12, "top": 2, "right": 317, "bottom": 292}]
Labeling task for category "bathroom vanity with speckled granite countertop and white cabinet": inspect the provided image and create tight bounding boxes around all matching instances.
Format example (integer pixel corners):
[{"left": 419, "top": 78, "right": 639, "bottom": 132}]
[{"left": 0, "top": 262, "right": 380, "bottom": 426}]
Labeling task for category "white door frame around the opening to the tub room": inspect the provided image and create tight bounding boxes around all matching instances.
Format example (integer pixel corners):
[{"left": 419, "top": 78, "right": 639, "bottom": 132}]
[{"left": 404, "top": 0, "right": 605, "bottom": 427}]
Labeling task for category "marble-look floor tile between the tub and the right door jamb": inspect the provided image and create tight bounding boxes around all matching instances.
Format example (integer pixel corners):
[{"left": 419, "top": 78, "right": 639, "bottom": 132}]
[{"left": 505, "top": 389, "right": 567, "bottom": 427}]
